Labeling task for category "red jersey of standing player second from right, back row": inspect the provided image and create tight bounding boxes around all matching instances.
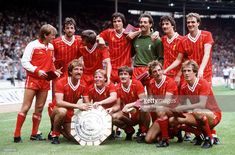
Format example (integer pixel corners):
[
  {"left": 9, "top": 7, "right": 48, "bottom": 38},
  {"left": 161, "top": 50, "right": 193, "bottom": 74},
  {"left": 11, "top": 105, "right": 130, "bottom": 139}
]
[{"left": 162, "top": 32, "right": 183, "bottom": 78}]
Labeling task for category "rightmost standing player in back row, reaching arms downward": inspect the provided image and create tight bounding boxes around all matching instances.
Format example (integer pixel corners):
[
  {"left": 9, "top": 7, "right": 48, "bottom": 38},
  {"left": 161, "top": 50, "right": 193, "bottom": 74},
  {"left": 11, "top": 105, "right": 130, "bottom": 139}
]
[{"left": 165, "top": 13, "right": 214, "bottom": 84}]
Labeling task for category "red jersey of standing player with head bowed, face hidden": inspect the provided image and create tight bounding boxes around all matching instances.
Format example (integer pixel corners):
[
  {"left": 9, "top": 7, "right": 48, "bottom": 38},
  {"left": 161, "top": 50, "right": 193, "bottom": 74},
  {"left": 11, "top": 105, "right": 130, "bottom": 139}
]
[{"left": 79, "top": 43, "right": 110, "bottom": 75}]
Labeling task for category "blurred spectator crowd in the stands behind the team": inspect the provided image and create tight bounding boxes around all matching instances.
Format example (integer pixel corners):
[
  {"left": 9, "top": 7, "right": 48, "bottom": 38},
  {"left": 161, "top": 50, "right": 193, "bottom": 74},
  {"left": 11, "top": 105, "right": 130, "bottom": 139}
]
[{"left": 0, "top": 8, "right": 235, "bottom": 79}]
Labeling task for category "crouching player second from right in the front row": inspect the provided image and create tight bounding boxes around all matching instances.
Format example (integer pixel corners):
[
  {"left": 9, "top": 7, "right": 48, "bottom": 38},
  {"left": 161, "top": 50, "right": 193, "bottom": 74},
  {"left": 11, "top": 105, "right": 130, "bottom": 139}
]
[{"left": 143, "top": 60, "right": 178, "bottom": 147}]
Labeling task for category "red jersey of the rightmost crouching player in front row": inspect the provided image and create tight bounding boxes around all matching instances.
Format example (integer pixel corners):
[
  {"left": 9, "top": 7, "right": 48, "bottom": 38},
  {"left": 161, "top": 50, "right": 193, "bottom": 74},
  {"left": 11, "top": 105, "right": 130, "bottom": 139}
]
[{"left": 180, "top": 78, "right": 220, "bottom": 112}]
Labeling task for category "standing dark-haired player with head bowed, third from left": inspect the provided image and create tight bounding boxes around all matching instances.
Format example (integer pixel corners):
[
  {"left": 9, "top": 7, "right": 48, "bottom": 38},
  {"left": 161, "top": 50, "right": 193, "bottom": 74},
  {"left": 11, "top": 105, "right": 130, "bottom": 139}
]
[{"left": 79, "top": 30, "right": 112, "bottom": 86}]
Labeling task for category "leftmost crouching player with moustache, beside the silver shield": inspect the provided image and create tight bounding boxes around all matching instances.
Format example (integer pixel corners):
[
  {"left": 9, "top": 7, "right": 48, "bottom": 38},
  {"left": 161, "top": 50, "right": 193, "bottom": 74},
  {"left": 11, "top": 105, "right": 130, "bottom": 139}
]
[{"left": 49, "top": 59, "right": 91, "bottom": 144}]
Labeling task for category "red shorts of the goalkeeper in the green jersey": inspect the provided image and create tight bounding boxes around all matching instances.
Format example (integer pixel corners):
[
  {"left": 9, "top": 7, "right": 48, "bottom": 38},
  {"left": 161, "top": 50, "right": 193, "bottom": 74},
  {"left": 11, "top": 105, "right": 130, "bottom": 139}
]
[{"left": 133, "top": 66, "right": 151, "bottom": 86}]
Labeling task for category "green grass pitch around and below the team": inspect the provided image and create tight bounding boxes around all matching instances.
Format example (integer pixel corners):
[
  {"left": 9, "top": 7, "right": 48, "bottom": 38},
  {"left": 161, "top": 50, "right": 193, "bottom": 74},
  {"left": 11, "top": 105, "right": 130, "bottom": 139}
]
[{"left": 0, "top": 87, "right": 235, "bottom": 155}]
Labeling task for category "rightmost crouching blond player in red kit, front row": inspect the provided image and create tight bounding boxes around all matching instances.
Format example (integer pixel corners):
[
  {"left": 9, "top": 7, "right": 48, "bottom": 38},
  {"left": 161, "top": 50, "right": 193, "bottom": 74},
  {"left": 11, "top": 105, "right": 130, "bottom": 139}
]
[{"left": 171, "top": 60, "right": 221, "bottom": 148}]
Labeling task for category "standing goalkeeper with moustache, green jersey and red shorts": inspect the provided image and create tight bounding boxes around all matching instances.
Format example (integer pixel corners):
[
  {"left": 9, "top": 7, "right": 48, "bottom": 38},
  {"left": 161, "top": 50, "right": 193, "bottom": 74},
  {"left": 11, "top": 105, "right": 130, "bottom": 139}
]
[{"left": 133, "top": 14, "right": 163, "bottom": 88}]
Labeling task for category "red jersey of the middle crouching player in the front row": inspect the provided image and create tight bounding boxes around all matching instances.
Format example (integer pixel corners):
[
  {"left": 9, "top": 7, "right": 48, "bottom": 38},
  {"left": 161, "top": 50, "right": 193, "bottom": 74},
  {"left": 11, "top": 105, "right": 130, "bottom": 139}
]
[{"left": 117, "top": 79, "right": 144, "bottom": 106}]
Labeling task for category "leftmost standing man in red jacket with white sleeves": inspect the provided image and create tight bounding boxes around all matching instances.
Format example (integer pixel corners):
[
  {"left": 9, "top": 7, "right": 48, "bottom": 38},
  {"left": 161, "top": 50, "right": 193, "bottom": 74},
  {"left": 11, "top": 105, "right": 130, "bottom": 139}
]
[{"left": 14, "top": 24, "right": 60, "bottom": 143}]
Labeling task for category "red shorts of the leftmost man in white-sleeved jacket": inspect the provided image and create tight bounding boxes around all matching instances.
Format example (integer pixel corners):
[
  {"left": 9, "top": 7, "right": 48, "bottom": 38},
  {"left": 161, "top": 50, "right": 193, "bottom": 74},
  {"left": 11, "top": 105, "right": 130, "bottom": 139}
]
[{"left": 25, "top": 76, "right": 50, "bottom": 91}]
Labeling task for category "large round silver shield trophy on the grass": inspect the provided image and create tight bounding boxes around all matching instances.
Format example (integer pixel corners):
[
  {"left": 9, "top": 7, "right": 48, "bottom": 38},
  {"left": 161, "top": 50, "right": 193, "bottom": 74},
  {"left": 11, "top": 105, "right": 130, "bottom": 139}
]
[{"left": 71, "top": 106, "right": 112, "bottom": 145}]
